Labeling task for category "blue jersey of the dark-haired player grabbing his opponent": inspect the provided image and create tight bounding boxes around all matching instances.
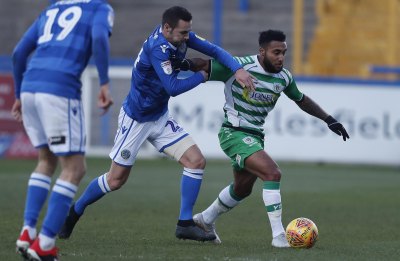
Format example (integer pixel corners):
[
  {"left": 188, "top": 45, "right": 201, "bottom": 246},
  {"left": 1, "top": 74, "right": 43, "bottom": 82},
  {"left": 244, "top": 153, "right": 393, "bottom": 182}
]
[{"left": 123, "top": 26, "right": 242, "bottom": 122}]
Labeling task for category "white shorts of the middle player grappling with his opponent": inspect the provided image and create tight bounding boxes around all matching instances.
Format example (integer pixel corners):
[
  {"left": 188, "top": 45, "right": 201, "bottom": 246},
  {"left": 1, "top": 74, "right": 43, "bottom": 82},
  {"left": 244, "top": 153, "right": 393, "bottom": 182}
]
[{"left": 110, "top": 108, "right": 195, "bottom": 166}]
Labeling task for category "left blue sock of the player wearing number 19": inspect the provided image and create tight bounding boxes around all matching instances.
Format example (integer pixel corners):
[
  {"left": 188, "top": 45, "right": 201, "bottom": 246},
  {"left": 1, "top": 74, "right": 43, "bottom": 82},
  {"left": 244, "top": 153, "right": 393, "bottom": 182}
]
[{"left": 24, "top": 172, "right": 51, "bottom": 225}]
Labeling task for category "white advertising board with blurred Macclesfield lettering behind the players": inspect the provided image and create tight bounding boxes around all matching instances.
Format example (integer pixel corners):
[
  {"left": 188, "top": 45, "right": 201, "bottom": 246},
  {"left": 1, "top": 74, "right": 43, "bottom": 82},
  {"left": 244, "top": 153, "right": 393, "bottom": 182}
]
[{"left": 84, "top": 67, "right": 400, "bottom": 166}]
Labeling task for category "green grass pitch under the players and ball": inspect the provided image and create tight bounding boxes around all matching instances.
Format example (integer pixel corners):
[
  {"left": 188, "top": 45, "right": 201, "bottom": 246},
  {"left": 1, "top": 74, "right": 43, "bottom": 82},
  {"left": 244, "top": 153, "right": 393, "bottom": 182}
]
[{"left": 0, "top": 159, "right": 400, "bottom": 261}]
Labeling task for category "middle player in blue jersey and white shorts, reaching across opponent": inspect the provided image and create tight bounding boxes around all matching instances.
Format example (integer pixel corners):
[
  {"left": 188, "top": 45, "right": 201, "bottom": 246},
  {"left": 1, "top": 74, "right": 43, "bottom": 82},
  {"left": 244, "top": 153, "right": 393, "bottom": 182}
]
[{"left": 59, "top": 6, "right": 253, "bottom": 241}]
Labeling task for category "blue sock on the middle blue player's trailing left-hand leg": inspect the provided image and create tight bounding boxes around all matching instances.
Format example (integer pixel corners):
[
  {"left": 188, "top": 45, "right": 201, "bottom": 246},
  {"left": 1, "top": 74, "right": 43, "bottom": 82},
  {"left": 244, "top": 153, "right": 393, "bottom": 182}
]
[{"left": 75, "top": 173, "right": 111, "bottom": 215}]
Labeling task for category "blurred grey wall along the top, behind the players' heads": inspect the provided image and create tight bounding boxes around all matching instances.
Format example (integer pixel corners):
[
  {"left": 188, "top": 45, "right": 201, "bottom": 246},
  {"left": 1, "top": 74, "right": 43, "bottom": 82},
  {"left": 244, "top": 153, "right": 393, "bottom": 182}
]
[{"left": 0, "top": 0, "right": 315, "bottom": 69}]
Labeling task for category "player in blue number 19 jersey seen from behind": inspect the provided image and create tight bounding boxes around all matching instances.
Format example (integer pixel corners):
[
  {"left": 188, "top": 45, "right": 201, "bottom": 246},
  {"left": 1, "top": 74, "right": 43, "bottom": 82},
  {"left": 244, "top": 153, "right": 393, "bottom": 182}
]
[{"left": 12, "top": 0, "right": 114, "bottom": 260}]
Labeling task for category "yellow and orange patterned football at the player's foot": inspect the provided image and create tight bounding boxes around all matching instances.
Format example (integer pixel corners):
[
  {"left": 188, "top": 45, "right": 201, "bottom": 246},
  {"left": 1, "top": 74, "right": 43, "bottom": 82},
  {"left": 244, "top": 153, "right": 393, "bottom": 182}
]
[{"left": 286, "top": 217, "right": 318, "bottom": 248}]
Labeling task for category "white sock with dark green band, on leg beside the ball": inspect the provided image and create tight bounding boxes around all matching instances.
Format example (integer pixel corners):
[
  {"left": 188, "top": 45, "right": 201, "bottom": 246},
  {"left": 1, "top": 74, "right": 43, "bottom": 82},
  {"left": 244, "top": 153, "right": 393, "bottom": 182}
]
[{"left": 263, "top": 181, "right": 285, "bottom": 237}]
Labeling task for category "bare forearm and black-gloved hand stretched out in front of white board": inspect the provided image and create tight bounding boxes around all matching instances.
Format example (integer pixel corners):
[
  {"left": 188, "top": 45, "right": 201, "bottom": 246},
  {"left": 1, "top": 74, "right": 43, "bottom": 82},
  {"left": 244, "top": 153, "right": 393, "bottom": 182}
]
[{"left": 296, "top": 94, "right": 350, "bottom": 141}]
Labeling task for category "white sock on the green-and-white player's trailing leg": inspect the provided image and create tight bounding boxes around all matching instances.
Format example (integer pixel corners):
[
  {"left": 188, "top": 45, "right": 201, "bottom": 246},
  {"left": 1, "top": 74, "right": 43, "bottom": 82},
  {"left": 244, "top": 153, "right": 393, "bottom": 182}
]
[{"left": 202, "top": 185, "right": 241, "bottom": 224}]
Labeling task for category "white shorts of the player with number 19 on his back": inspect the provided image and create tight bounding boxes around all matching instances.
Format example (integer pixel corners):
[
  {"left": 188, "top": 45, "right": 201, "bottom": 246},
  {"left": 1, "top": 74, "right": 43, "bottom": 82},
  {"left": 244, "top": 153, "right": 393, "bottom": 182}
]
[{"left": 21, "top": 92, "right": 86, "bottom": 156}]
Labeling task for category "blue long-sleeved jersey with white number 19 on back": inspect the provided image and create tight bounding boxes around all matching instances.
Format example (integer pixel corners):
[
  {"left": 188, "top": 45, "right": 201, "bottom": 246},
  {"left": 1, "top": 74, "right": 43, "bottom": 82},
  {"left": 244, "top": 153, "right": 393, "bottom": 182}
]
[{"left": 13, "top": 0, "right": 114, "bottom": 99}]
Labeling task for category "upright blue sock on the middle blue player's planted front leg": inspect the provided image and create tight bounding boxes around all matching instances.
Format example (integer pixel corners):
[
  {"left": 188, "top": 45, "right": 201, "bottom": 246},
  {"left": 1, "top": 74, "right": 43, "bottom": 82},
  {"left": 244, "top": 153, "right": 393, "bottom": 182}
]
[{"left": 179, "top": 168, "right": 204, "bottom": 220}]
